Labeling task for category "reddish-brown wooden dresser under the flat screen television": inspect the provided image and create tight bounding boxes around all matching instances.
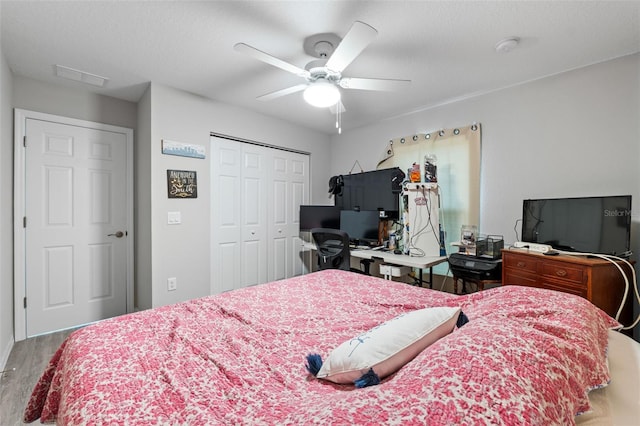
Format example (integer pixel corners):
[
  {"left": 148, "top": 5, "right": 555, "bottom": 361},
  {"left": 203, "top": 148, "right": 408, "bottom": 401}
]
[{"left": 502, "top": 249, "right": 634, "bottom": 326}]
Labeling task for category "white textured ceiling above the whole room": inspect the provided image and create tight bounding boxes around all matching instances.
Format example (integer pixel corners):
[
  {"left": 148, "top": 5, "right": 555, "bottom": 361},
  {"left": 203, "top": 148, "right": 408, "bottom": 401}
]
[{"left": 0, "top": 0, "right": 640, "bottom": 134}]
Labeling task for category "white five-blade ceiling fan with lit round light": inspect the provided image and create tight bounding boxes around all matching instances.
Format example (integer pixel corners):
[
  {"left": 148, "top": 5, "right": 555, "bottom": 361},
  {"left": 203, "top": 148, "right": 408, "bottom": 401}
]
[{"left": 234, "top": 21, "right": 411, "bottom": 115}]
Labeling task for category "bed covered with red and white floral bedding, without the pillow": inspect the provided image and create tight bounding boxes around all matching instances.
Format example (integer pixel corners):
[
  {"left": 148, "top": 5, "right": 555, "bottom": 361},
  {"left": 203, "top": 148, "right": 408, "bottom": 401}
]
[{"left": 24, "top": 270, "right": 640, "bottom": 425}]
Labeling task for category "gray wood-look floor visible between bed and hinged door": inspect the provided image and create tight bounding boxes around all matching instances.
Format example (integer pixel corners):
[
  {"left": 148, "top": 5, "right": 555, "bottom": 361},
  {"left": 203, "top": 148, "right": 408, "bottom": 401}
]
[{"left": 0, "top": 330, "right": 73, "bottom": 426}]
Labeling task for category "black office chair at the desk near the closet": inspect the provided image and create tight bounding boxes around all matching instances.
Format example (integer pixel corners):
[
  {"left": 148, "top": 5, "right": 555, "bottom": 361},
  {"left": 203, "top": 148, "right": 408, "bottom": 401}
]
[{"left": 311, "top": 228, "right": 371, "bottom": 275}]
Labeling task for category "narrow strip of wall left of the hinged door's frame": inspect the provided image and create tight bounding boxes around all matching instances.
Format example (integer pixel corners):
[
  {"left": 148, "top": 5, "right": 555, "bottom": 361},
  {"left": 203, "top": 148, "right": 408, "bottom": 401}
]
[{"left": 0, "top": 47, "right": 13, "bottom": 370}]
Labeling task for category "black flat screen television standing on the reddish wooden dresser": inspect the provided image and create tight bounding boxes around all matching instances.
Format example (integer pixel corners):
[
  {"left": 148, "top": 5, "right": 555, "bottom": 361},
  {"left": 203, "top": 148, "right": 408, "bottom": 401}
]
[{"left": 522, "top": 195, "right": 631, "bottom": 257}]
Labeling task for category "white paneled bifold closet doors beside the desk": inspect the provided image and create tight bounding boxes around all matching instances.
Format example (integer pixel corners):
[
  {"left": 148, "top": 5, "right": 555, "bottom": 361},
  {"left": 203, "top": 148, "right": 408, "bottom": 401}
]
[{"left": 211, "top": 136, "right": 309, "bottom": 294}]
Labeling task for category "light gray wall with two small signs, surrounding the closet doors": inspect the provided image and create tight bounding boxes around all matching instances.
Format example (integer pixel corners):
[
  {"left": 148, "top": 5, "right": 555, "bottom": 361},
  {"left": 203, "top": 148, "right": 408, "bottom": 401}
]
[{"left": 138, "top": 84, "right": 330, "bottom": 307}]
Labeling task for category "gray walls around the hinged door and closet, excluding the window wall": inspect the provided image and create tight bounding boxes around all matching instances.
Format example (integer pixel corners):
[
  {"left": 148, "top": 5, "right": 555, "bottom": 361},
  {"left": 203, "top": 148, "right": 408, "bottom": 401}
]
[{"left": 0, "top": 70, "right": 330, "bottom": 356}]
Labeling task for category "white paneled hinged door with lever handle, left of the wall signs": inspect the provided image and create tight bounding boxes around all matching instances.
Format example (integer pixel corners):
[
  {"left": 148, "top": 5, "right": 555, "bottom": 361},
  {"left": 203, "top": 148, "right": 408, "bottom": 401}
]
[{"left": 15, "top": 110, "right": 132, "bottom": 337}]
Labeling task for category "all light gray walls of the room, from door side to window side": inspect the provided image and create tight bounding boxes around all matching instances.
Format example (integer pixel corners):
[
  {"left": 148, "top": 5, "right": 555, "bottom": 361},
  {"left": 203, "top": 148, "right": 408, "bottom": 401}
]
[{"left": 0, "top": 52, "right": 640, "bottom": 363}]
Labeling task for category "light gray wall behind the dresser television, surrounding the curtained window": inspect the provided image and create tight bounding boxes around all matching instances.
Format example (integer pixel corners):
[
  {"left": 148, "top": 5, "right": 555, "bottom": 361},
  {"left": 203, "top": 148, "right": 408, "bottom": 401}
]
[{"left": 331, "top": 54, "right": 640, "bottom": 340}]
